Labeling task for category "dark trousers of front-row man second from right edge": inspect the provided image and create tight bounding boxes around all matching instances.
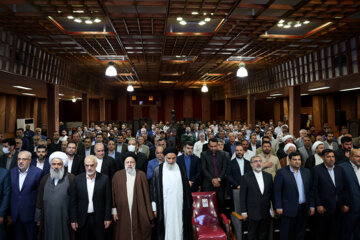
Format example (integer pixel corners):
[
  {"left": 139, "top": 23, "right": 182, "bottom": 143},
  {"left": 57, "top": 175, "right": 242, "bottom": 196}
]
[{"left": 313, "top": 206, "right": 341, "bottom": 240}]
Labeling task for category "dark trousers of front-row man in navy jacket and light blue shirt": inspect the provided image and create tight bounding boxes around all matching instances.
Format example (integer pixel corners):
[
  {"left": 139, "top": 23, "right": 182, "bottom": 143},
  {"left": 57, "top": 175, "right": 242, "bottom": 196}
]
[{"left": 280, "top": 204, "right": 308, "bottom": 240}]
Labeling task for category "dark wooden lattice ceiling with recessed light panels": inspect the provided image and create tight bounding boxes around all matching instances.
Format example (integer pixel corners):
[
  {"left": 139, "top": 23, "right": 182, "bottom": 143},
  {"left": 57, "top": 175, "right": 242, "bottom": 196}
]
[{"left": 0, "top": 0, "right": 360, "bottom": 88}]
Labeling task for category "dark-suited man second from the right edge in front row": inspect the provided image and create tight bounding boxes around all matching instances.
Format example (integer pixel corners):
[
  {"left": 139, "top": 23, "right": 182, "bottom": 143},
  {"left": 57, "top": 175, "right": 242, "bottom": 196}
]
[{"left": 312, "top": 149, "right": 345, "bottom": 240}]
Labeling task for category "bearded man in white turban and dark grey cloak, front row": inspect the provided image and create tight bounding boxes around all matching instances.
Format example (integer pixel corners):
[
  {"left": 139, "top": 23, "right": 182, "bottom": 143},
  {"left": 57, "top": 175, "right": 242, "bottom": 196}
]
[{"left": 35, "top": 152, "right": 75, "bottom": 240}]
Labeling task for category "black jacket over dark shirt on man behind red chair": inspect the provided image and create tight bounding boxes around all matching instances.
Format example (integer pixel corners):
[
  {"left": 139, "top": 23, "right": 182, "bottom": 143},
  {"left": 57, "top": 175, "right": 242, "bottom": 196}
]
[{"left": 201, "top": 149, "right": 228, "bottom": 189}]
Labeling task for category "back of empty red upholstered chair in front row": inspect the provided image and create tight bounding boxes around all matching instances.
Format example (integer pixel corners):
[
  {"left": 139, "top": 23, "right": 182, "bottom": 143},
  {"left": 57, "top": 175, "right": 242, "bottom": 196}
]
[{"left": 192, "top": 192, "right": 219, "bottom": 226}]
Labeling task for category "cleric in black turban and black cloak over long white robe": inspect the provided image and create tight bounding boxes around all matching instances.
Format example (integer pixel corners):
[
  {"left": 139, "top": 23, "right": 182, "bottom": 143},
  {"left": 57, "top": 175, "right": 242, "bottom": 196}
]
[{"left": 150, "top": 147, "right": 192, "bottom": 240}]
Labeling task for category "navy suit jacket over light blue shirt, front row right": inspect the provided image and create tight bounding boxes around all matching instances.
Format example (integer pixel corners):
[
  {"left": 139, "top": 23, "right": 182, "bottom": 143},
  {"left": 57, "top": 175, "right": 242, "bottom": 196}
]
[{"left": 274, "top": 166, "right": 314, "bottom": 217}]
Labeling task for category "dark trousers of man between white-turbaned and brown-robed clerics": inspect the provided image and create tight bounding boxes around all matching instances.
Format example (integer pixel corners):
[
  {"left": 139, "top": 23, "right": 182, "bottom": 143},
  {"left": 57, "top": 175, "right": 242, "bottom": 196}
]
[{"left": 78, "top": 213, "right": 105, "bottom": 240}]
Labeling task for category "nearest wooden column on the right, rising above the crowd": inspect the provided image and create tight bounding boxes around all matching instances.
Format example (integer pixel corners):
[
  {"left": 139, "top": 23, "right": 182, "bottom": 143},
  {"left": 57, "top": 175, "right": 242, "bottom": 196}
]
[{"left": 289, "top": 86, "right": 301, "bottom": 137}]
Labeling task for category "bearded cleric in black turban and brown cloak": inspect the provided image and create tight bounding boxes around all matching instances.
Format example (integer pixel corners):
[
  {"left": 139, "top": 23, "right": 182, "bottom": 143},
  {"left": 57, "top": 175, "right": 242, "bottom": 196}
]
[{"left": 112, "top": 152, "right": 154, "bottom": 240}]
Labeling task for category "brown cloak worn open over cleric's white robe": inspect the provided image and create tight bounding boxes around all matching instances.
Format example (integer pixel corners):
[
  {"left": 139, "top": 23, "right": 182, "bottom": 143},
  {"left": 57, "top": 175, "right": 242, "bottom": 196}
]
[{"left": 112, "top": 169, "right": 154, "bottom": 240}]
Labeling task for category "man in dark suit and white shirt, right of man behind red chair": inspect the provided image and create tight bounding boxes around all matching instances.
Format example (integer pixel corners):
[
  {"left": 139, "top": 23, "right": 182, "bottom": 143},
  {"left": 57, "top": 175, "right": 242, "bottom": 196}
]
[{"left": 226, "top": 145, "right": 251, "bottom": 193}]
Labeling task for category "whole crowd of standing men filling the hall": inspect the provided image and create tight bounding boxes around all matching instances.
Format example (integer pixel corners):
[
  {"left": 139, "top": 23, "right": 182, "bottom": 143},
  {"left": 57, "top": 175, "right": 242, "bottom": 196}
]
[{"left": 0, "top": 120, "right": 360, "bottom": 240}]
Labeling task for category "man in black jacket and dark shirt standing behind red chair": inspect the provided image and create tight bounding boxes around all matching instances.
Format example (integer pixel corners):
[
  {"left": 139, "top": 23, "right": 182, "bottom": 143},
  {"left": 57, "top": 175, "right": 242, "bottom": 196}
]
[{"left": 201, "top": 138, "right": 228, "bottom": 212}]
